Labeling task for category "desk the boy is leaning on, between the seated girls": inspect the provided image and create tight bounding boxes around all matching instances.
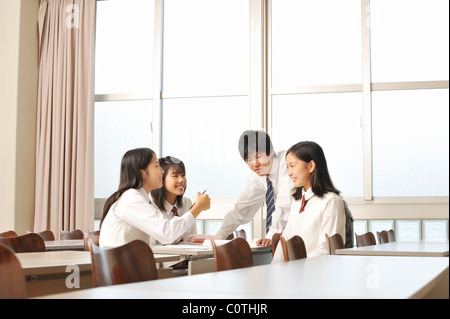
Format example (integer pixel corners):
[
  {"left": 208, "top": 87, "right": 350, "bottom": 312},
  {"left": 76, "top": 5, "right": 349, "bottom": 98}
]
[{"left": 152, "top": 243, "right": 272, "bottom": 275}]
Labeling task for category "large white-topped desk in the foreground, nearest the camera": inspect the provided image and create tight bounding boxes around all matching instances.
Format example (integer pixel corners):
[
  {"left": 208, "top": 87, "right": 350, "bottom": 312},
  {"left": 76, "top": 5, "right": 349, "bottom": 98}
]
[{"left": 37, "top": 255, "right": 449, "bottom": 304}]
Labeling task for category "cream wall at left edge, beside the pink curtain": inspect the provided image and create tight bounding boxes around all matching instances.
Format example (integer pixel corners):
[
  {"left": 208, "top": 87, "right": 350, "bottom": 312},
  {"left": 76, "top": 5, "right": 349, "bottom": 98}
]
[{"left": 0, "top": 0, "right": 39, "bottom": 234}]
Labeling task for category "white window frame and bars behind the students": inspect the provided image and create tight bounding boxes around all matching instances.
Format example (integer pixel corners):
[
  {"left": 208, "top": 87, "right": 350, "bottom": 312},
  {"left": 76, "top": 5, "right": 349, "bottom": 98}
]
[{"left": 95, "top": 0, "right": 449, "bottom": 238}]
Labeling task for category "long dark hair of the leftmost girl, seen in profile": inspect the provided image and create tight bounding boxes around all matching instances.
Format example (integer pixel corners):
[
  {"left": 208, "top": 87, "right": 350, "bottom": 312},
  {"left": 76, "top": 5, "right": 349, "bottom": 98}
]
[{"left": 100, "top": 148, "right": 156, "bottom": 227}]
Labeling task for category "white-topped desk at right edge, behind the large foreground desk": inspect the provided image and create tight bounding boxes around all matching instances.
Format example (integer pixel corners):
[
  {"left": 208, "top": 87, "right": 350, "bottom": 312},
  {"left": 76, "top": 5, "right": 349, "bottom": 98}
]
[{"left": 336, "top": 241, "right": 449, "bottom": 257}]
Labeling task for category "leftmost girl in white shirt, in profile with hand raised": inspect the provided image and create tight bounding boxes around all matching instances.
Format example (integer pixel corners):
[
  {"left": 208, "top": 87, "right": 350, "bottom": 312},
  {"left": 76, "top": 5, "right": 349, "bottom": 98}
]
[{"left": 100, "top": 148, "right": 210, "bottom": 247}]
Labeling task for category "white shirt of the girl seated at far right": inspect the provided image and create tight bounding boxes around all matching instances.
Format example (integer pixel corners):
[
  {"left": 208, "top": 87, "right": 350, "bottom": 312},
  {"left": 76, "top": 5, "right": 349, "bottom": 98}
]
[{"left": 272, "top": 188, "right": 345, "bottom": 263}]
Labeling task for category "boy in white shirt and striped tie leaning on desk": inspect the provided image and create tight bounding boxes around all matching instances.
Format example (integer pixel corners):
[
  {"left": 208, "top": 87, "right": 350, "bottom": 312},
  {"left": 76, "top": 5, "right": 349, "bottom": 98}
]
[{"left": 216, "top": 130, "right": 293, "bottom": 246}]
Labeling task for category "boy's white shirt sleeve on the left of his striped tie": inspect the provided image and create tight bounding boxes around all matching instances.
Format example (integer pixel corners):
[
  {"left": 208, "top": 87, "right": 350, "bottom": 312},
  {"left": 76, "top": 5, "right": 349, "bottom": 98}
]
[{"left": 216, "top": 174, "right": 265, "bottom": 238}]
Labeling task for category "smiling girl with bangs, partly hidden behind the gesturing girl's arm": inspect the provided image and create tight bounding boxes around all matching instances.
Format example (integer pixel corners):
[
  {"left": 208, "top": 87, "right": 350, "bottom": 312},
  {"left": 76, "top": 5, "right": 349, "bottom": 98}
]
[{"left": 151, "top": 156, "right": 197, "bottom": 243}]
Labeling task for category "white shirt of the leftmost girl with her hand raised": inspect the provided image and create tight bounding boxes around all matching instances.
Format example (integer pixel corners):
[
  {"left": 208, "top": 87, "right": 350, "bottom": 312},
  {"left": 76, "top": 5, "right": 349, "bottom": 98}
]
[{"left": 99, "top": 188, "right": 195, "bottom": 247}]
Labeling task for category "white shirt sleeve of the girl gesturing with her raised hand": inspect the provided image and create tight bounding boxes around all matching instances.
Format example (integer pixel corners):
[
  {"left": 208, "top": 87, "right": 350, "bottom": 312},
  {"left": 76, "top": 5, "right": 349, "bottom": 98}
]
[{"left": 116, "top": 193, "right": 195, "bottom": 244}]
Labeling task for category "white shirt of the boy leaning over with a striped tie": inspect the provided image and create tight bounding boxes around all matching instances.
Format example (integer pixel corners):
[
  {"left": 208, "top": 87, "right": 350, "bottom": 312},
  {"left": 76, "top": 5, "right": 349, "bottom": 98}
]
[{"left": 216, "top": 151, "right": 294, "bottom": 238}]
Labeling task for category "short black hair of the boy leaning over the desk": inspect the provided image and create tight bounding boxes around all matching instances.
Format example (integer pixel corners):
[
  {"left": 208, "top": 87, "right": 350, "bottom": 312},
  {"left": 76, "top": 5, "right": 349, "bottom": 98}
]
[{"left": 238, "top": 130, "right": 276, "bottom": 161}]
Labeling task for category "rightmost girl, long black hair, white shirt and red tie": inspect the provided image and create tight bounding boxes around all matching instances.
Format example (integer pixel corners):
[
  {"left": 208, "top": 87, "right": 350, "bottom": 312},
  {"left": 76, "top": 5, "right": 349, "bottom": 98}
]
[{"left": 273, "top": 142, "right": 345, "bottom": 262}]
